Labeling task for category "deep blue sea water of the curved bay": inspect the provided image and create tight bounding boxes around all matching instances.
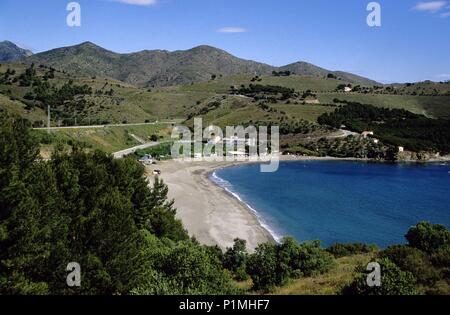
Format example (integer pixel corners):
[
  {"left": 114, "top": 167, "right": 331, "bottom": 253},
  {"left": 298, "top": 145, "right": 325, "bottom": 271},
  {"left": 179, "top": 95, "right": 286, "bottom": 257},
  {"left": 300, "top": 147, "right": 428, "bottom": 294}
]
[{"left": 211, "top": 161, "right": 450, "bottom": 248}]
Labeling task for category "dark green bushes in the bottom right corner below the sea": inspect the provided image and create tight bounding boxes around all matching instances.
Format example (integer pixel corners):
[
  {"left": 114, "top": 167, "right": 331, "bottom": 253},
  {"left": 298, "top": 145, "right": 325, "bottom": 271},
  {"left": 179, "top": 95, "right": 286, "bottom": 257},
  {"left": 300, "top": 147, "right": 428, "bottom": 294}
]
[{"left": 343, "top": 222, "right": 450, "bottom": 295}]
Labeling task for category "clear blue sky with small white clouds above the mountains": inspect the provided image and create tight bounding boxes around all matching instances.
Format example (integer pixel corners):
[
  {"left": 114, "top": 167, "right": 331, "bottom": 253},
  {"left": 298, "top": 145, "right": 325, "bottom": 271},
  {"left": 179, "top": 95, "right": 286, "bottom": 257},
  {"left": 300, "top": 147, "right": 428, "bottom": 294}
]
[{"left": 0, "top": 0, "right": 450, "bottom": 82}]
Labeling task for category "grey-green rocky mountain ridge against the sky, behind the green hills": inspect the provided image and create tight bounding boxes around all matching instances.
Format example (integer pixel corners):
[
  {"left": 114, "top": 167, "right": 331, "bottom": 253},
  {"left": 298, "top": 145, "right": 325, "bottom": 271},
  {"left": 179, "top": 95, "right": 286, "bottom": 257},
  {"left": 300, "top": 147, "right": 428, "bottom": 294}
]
[{"left": 24, "top": 42, "right": 376, "bottom": 87}]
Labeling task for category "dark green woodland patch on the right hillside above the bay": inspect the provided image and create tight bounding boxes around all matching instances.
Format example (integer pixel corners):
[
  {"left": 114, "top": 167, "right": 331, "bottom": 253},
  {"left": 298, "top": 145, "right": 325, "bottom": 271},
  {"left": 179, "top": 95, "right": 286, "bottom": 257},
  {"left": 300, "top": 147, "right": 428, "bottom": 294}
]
[{"left": 318, "top": 102, "right": 450, "bottom": 154}]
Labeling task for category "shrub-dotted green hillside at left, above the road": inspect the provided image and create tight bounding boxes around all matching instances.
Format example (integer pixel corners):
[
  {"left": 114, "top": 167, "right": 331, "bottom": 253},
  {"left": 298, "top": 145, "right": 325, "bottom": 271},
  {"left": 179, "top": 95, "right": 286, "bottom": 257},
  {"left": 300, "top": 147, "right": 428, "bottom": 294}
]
[{"left": 0, "top": 64, "right": 209, "bottom": 127}]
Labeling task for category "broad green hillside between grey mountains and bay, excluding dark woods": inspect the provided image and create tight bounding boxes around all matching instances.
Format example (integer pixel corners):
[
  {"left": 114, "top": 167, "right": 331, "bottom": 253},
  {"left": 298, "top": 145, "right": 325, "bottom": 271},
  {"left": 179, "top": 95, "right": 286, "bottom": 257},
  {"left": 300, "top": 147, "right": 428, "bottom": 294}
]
[{"left": 0, "top": 64, "right": 450, "bottom": 157}]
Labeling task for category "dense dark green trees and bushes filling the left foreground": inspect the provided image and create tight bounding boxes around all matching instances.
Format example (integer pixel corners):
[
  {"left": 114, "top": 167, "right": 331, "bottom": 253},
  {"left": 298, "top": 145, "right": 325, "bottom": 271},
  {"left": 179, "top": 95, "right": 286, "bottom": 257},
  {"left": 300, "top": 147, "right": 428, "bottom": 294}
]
[{"left": 0, "top": 112, "right": 333, "bottom": 294}]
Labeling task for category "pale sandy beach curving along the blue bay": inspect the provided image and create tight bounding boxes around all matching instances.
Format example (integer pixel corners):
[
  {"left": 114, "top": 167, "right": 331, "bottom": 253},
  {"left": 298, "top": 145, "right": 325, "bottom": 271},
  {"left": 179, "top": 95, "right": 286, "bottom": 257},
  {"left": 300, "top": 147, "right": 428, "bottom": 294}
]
[{"left": 147, "top": 156, "right": 352, "bottom": 250}]
